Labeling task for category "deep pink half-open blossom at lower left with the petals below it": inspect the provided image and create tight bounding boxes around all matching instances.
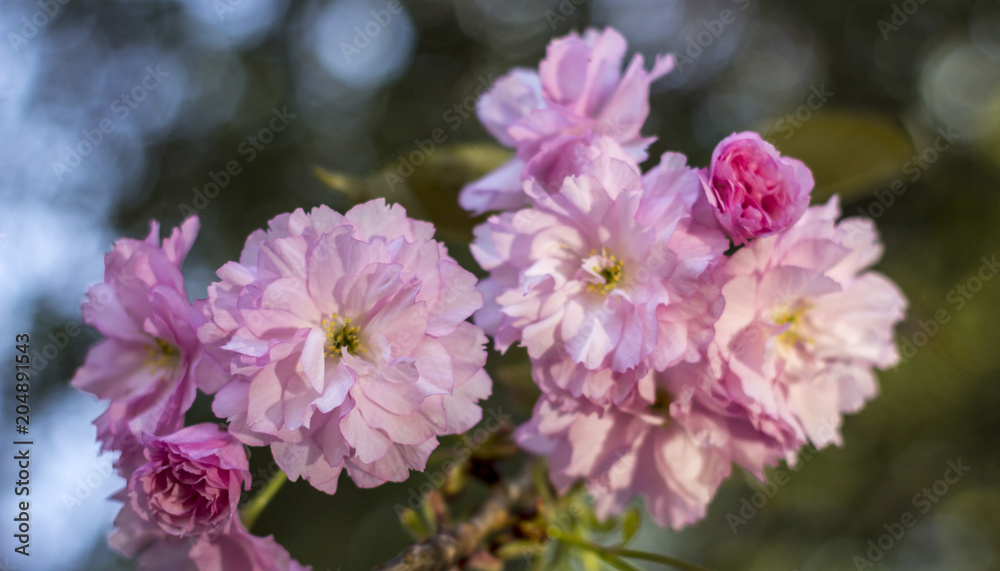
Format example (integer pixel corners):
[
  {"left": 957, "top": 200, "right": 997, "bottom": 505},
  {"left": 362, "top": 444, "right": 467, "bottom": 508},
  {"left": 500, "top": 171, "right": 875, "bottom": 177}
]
[{"left": 110, "top": 424, "right": 307, "bottom": 571}]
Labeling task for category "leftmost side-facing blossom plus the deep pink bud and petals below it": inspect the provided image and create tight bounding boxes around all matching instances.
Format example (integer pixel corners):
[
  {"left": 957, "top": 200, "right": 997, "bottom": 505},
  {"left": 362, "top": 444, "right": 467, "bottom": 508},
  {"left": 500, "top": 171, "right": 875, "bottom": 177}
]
[{"left": 72, "top": 218, "right": 305, "bottom": 571}]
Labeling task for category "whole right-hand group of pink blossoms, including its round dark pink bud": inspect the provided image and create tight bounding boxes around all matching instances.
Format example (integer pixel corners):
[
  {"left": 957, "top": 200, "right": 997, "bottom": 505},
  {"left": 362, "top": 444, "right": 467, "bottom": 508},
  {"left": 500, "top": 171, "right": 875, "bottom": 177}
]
[{"left": 460, "top": 25, "right": 906, "bottom": 528}]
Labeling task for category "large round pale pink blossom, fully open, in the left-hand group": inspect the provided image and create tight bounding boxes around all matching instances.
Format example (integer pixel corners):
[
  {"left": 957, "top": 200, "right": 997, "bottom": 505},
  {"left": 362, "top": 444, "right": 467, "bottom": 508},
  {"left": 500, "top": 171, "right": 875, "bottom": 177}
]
[{"left": 199, "top": 199, "right": 491, "bottom": 493}]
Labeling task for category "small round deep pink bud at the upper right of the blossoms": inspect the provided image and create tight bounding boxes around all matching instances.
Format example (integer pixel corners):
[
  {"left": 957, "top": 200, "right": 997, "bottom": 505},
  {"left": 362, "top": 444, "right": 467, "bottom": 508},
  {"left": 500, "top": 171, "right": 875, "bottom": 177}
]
[{"left": 702, "top": 132, "right": 813, "bottom": 244}]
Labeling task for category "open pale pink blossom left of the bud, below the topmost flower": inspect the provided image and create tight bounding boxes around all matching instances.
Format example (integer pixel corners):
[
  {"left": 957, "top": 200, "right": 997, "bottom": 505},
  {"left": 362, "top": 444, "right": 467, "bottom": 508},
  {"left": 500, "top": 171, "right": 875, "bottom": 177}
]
[{"left": 472, "top": 140, "right": 728, "bottom": 401}]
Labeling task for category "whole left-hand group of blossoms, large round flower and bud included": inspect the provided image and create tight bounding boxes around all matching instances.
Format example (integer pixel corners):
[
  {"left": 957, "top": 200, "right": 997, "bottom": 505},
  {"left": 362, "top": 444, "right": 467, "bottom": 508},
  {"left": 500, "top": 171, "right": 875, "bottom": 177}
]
[{"left": 72, "top": 200, "right": 492, "bottom": 571}]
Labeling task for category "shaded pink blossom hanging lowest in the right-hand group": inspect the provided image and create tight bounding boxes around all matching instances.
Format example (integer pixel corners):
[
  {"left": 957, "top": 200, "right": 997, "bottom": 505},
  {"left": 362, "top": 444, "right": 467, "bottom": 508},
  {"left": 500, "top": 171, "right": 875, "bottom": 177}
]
[{"left": 516, "top": 363, "right": 782, "bottom": 529}]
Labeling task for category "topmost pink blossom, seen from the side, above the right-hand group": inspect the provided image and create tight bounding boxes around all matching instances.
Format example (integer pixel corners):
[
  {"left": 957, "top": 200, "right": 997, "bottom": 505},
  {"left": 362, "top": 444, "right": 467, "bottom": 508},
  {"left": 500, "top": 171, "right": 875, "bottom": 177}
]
[{"left": 459, "top": 28, "right": 674, "bottom": 214}]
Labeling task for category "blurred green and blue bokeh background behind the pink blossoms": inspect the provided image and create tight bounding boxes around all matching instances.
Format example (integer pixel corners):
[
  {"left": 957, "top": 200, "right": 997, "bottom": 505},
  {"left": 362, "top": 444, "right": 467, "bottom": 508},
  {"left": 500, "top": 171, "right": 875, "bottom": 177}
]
[{"left": 0, "top": 0, "right": 1000, "bottom": 571}]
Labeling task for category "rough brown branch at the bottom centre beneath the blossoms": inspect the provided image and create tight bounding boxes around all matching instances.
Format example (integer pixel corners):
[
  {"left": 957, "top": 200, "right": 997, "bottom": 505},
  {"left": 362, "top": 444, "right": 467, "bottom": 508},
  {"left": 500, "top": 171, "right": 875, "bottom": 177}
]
[{"left": 375, "top": 472, "right": 531, "bottom": 571}]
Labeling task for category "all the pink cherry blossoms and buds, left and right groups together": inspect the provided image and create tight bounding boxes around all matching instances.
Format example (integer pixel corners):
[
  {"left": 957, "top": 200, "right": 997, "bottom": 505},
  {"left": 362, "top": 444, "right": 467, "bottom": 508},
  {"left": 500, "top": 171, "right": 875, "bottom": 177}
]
[{"left": 66, "top": 23, "right": 906, "bottom": 571}]
